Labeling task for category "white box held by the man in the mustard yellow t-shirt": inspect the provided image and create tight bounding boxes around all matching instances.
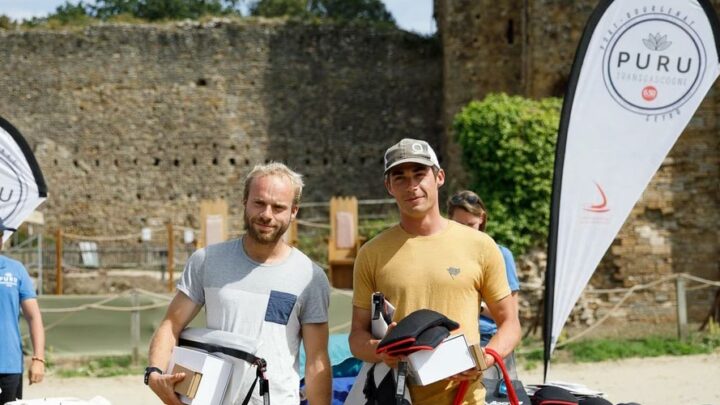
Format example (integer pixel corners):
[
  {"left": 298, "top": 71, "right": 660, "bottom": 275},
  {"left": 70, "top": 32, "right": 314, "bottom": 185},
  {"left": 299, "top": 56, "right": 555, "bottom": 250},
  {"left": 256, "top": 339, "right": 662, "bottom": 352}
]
[{"left": 408, "top": 334, "right": 475, "bottom": 385}]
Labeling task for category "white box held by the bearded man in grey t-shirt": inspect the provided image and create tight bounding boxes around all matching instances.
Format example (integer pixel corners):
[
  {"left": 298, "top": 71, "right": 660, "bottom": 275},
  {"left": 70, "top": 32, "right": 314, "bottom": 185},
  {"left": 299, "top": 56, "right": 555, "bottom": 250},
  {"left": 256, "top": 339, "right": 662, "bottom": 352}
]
[{"left": 167, "top": 346, "right": 233, "bottom": 405}]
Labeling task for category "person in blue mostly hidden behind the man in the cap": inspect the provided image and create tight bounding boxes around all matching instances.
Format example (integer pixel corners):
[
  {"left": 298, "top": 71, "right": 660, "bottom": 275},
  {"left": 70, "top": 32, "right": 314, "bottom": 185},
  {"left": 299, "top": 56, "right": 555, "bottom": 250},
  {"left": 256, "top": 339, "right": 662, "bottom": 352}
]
[{"left": 447, "top": 190, "right": 520, "bottom": 379}]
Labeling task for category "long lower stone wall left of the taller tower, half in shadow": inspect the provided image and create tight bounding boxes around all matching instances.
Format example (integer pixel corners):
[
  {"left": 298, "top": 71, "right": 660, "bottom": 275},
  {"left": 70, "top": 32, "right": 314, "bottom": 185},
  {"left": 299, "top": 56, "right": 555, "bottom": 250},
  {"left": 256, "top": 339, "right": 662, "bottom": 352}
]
[{"left": 0, "top": 20, "right": 442, "bottom": 235}]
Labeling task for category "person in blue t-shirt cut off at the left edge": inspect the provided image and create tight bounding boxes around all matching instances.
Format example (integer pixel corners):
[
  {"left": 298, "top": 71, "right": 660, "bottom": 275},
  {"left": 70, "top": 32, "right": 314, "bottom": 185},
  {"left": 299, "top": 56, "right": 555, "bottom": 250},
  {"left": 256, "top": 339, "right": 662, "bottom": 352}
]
[{"left": 0, "top": 220, "right": 45, "bottom": 405}]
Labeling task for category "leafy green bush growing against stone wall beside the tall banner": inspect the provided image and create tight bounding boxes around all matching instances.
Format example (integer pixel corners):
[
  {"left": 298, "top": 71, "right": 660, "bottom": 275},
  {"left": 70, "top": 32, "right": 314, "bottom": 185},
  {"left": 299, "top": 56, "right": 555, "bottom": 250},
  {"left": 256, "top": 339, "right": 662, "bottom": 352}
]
[{"left": 453, "top": 94, "right": 561, "bottom": 254}]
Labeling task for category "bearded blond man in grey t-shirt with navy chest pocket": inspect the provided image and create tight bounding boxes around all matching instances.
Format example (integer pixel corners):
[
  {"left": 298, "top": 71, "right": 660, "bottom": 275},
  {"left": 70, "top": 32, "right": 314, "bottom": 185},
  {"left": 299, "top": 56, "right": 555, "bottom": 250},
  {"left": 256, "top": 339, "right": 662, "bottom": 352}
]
[{"left": 151, "top": 163, "right": 331, "bottom": 405}]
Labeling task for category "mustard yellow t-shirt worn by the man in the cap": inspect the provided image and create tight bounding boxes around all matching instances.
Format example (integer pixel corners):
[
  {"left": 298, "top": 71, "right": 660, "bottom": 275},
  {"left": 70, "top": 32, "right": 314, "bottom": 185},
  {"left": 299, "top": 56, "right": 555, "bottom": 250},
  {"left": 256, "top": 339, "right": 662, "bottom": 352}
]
[{"left": 353, "top": 221, "right": 510, "bottom": 405}]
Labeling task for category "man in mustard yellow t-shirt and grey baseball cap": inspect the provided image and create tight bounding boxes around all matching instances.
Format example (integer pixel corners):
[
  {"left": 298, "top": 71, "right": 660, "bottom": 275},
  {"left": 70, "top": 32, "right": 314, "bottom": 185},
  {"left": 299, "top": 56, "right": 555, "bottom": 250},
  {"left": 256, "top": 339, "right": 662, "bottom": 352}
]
[{"left": 350, "top": 138, "right": 520, "bottom": 405}]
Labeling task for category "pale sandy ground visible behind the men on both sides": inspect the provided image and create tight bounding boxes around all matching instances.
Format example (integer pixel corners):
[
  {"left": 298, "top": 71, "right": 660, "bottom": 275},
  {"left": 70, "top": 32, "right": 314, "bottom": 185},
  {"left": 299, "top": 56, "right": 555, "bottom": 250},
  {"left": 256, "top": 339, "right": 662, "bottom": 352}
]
[{"left": 25, "top": 353, "right": 720, "bottom": 405}]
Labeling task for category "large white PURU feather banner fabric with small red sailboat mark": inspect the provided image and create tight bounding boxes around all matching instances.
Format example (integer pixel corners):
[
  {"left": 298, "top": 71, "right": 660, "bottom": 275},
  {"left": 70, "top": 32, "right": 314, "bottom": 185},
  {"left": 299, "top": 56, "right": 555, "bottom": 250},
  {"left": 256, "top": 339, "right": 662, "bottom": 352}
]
[{"left": 551, "top": 0, "right": 719, "bottom": 356}]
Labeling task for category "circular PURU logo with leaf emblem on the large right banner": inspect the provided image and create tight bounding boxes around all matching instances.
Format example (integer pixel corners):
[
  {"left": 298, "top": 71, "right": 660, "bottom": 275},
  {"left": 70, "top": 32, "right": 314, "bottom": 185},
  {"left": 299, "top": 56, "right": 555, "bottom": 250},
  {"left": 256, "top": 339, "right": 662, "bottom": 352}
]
[{"left": 602, "top": 6, "right": 706, "bottom": 118}]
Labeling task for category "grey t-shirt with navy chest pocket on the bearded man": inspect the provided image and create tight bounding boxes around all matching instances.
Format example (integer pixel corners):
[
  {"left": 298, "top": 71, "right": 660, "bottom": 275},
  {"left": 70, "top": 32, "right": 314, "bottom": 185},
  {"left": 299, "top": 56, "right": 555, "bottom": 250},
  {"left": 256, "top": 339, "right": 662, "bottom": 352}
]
[{"left": 177, "top": 239, "right": 330, "bottom": 405}]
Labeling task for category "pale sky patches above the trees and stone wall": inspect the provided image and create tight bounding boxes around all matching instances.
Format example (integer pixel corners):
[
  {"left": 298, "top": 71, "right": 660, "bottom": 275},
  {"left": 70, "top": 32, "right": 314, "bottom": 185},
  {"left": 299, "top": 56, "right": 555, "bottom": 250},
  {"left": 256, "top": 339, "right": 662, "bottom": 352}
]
[{"left": 0, "top": 0, "right": 436, "bottom": 34}]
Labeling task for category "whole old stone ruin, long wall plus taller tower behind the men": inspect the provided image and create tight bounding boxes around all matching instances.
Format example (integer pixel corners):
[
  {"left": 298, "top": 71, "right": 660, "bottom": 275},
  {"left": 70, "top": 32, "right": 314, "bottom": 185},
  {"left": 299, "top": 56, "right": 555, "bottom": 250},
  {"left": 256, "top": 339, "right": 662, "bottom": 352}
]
[{"left": 0, "top": 4, "right": 720, "bottom": 322}]
